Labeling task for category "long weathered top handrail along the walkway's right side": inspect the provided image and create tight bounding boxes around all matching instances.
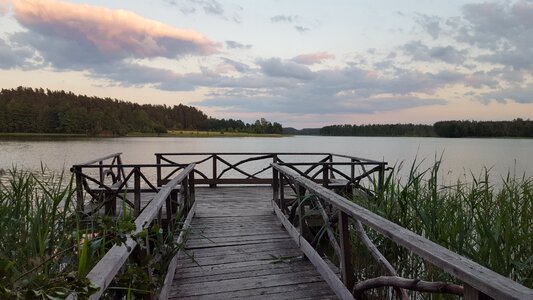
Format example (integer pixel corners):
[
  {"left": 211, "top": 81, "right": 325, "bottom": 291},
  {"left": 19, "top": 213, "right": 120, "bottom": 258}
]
[{"left": 272, "top": 163, "right": 533, "bottom": 299}]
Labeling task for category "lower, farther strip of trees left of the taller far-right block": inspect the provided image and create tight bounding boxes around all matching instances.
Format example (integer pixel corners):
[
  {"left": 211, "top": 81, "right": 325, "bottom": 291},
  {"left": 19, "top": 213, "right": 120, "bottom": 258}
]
[{"left": 320, "top": 124, "right": 435, "bottom": 137}]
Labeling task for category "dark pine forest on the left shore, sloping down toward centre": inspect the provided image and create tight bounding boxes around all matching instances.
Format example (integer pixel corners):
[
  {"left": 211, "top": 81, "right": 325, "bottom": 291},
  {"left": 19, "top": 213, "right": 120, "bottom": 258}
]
[{"left": 0, "top": 87, "right": 282, "bottom": 136}]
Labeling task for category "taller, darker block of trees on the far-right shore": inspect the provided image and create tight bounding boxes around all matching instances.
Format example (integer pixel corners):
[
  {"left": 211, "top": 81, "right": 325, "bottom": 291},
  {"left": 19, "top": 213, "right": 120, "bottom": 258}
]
[{"left": 433, "top": 119, "right": 533, "bottom": 137}]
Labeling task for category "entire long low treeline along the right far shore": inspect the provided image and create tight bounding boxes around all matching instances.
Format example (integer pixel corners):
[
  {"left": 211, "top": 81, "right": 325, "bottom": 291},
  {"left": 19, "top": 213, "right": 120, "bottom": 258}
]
[{"left": 319, "top": 119, "right": 533, "bottom": 137}]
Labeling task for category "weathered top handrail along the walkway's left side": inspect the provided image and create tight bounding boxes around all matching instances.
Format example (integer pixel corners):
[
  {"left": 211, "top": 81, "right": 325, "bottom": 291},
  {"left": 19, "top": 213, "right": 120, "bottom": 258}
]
[{"left": 87, "top": 164, "right": 194, "bottom": 299}]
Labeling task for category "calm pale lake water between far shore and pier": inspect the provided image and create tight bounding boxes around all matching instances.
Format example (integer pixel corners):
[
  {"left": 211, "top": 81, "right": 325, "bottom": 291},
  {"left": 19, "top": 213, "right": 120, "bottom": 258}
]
[{"left": 0, "top": 136, "right": 533, "bottom": 179}]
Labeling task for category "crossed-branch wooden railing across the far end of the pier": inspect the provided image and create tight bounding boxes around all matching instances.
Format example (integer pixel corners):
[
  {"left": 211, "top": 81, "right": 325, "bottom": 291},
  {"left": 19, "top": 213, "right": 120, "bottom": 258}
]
[{"left": 155, "top": 152, "right": 387, "bottom": 187}]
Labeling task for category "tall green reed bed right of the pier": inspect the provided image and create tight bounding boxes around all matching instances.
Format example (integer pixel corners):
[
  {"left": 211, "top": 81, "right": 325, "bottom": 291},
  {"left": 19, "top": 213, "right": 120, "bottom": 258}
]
[{"left": 353, "top": 161, "right": 533, "bottom": 288}]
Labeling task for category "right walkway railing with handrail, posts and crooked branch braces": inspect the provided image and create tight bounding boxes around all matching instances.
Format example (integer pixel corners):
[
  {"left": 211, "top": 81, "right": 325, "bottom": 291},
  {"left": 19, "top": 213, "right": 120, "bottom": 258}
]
[{"left": 272, "top": 163, "right": 533, "bottom": 300}]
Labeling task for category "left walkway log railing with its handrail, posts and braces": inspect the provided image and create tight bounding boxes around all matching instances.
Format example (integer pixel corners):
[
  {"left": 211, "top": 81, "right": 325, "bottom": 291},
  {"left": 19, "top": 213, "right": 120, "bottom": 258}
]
[{"left": 79, "top": 164, "right": 195, "bottom": 299}]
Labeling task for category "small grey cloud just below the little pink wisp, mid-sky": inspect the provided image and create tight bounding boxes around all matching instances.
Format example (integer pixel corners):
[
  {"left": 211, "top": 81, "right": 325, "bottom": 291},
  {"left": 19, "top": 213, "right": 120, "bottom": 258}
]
[{"left": 257, "top": 58, "right": 314, "bottom": 80}]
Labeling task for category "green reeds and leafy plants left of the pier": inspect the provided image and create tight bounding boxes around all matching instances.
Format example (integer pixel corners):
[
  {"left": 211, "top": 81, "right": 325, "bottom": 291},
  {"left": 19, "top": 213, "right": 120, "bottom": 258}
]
[{"left": 0, "top": 169, "right": 183, "bottom": 299}]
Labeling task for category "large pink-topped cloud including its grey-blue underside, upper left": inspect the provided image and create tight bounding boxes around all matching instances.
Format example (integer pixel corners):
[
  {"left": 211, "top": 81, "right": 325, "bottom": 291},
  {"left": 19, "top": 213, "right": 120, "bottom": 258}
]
[{"left": 5, "top": 0, "right": 219, "bottom": 66}]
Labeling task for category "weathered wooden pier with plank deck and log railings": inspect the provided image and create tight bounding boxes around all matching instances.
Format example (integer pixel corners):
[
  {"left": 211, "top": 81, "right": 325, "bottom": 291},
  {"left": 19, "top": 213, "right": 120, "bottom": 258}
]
[{"left": 70, "top": 153, "right": 533, "bottom": 300}]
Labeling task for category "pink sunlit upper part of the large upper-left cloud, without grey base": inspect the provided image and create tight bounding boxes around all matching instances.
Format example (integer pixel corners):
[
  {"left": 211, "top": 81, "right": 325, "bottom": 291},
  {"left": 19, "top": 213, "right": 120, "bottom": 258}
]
[{"left": 6, "top": 0, "right": 220, "bottom": 58}]
